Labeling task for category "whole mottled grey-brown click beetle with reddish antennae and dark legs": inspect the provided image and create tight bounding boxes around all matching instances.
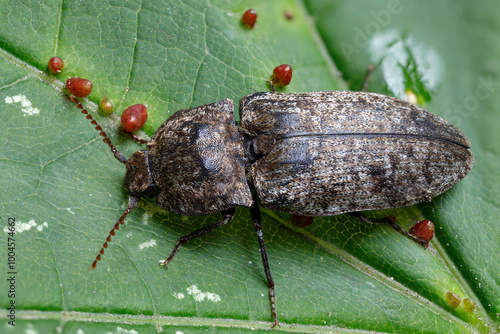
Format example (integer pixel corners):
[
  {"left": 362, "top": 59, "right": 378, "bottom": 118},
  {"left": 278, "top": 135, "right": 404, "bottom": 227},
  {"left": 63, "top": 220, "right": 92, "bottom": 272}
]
[{"left": 78, "top": 91, "right": 474, "bottom": 325}]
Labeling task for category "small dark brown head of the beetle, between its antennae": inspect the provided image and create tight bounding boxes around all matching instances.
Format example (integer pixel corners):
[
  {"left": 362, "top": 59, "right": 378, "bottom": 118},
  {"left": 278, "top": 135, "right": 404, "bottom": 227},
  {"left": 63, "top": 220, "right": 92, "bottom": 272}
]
[{"left": 125, "top": 151, "right": 158, "bottom": 197}]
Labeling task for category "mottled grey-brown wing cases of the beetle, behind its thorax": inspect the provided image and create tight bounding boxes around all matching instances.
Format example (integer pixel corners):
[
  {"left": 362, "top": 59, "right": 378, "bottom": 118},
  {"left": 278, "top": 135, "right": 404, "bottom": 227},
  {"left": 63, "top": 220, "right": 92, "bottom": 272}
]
[{"left": 240, "top": 91, "right": 473, "bottom": 216}]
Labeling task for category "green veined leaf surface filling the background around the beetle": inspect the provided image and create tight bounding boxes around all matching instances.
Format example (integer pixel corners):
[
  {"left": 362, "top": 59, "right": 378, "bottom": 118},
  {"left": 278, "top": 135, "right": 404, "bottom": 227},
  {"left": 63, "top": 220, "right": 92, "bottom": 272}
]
[{"left": 0, "top": 0, "right": 500, "bottom": 333}]
